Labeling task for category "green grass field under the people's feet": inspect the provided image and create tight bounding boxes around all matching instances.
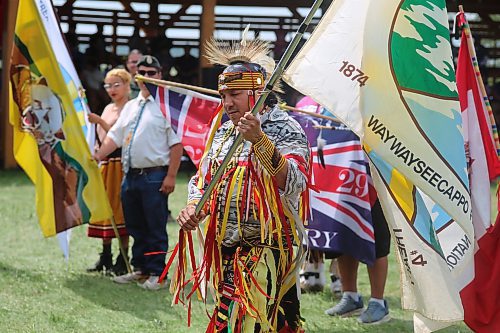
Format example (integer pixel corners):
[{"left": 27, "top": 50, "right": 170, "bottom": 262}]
[{"left": 0, "top": 171, "right": 470, "bottom": 333}]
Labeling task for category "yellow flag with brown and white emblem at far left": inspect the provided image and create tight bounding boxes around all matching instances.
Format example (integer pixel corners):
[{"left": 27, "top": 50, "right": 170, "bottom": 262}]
[{"left": 10, "top": 0, "right": 112, "bottom": 236}]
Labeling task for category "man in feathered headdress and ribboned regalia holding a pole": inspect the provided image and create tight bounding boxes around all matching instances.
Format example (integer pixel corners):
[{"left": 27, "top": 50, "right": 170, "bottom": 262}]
[{"left": 173, "top": 29, "right": 310, "bottom": 332}]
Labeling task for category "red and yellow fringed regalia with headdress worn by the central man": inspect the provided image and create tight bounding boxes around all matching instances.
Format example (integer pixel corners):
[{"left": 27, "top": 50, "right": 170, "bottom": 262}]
[{"left": 161, "top": 29, "right": 310, "bottom": 333}]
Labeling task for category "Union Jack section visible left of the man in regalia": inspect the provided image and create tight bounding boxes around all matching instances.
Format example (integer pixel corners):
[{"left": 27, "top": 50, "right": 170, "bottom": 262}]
[{"left": 146, "top": 83, "right": 220, "bottom": 167}]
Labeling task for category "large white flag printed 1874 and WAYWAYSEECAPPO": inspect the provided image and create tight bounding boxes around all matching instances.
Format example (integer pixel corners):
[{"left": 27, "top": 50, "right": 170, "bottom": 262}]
[{"left": 284, "top": 0, "right": 474, "bottom": 331}]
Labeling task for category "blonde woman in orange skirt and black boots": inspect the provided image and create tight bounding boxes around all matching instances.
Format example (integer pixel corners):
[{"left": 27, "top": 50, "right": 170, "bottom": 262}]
[{"left": 87, "top": 68, "right": 132, "bottom": 275}]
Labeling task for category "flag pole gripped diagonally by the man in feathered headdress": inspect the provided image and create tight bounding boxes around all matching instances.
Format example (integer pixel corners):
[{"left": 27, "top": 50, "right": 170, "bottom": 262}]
[{"left": 191, "top": 0, "right": 323, "bottom": 215}]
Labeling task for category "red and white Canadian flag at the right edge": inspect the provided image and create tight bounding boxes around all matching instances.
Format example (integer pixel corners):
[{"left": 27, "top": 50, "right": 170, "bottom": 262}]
[{"left": 457, "top": 12, "right": 500, "bottom": 333}]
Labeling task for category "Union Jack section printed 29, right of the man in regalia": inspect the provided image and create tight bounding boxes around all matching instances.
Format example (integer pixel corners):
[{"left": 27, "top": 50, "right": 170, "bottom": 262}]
[{"left": 293, "top": 111, "right": 376, "bottom": 264}]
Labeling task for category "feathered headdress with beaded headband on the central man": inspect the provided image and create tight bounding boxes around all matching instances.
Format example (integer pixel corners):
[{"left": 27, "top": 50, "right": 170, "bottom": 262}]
[{"left": 205, "top": 26, "right": 281, "bottom": 96}]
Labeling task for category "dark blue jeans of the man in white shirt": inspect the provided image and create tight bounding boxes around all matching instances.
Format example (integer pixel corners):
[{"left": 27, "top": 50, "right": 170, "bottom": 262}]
[{"left": 121, "top": 169, "right": 168, "bottom": 275}]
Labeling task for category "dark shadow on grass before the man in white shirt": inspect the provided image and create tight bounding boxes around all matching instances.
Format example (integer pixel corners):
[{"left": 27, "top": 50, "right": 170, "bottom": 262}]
[{"left": 65, "top": 273, "right": 182, "bottom": 321}]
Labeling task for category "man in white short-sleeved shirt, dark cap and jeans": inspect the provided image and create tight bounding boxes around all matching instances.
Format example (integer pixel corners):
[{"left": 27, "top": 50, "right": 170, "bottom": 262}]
[{"left": 94, "top": 55, "right": 182, "bottom": 290}]
